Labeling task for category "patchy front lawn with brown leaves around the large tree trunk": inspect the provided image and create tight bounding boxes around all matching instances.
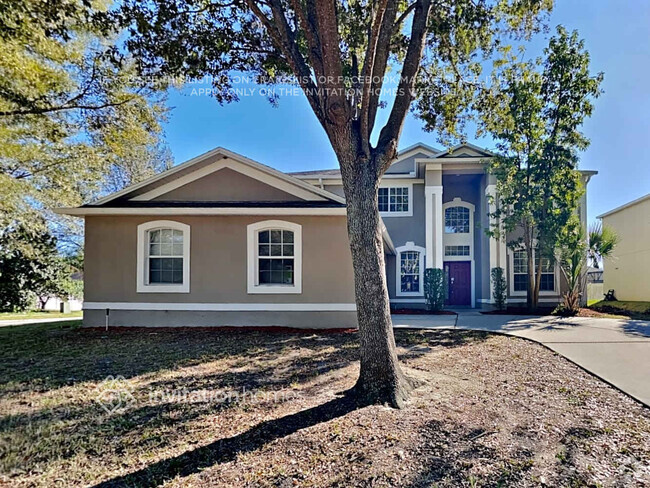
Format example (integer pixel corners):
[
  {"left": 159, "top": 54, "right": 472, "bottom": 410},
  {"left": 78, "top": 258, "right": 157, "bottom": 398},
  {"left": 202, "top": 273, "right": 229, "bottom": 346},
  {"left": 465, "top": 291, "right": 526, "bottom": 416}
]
[{"left": 0, "top": 324, "right": 650, "bottom": 487}]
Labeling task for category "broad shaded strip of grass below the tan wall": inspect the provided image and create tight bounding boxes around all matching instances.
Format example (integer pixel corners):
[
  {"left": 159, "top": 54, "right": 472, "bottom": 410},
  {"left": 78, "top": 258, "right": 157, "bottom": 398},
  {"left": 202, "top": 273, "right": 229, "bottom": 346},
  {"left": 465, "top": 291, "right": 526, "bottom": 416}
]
[{"left": 0, "top": 324, "right": 351, "bottom": 393}]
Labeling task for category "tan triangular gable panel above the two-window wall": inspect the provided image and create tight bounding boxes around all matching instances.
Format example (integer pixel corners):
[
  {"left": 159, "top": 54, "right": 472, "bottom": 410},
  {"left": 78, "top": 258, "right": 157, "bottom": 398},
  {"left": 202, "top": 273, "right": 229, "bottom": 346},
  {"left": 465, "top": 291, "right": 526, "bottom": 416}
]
[{"left": 153, "top": 168, "right": 301, "bottom": 202}]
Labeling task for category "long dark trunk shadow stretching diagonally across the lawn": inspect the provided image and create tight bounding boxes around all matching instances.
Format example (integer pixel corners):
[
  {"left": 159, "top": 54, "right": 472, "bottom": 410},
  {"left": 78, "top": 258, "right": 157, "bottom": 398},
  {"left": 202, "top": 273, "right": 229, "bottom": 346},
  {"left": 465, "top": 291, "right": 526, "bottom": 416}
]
[{"left": 95, "top": 396, "right": 362, "bottom": 488}]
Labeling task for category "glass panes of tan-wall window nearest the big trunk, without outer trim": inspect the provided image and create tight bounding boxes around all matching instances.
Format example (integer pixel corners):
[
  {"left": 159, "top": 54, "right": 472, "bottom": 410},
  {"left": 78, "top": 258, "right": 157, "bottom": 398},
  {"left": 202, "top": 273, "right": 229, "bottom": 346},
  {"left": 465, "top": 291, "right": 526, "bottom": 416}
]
[{"left": 258, "top": 229, "right": 294, "bottom": 285}]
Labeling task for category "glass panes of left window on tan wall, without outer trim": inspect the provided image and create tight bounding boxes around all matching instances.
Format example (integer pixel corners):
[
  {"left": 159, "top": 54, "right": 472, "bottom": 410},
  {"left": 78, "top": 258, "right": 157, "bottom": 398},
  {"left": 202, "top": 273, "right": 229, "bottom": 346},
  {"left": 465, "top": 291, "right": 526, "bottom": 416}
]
[{"left": 148, "top": 229, "right": 183, "bottom": 284}]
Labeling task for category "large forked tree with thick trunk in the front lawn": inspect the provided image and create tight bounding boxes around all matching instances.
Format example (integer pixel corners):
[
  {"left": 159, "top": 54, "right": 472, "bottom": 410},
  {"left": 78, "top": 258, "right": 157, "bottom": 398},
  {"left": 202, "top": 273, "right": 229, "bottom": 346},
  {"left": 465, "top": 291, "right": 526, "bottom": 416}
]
[{"left": 116, "top": 0, "right": 553, "bottom": 406}]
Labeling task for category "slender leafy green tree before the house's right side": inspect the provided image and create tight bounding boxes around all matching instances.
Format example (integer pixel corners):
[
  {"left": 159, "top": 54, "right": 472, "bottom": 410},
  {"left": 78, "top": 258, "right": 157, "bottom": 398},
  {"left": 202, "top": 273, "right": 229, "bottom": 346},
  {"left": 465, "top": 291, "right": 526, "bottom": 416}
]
[{"left": 481, "top": 27, "right": 603, "bottom": 308}]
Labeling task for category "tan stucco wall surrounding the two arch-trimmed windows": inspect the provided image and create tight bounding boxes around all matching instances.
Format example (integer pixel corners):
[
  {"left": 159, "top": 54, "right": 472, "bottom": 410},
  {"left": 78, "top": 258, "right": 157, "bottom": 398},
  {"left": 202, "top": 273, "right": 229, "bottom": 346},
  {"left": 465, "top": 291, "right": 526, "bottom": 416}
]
[{"left": 84, "top": 216, "right": 356, "bottom": 327}]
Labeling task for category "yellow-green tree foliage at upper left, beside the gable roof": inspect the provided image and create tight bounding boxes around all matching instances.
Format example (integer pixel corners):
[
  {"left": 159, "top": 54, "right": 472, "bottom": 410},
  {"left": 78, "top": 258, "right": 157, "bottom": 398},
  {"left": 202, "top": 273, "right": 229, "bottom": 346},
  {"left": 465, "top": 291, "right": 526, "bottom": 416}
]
[{"left": 0, "top": 0, "right": 170, "bottom": 246}]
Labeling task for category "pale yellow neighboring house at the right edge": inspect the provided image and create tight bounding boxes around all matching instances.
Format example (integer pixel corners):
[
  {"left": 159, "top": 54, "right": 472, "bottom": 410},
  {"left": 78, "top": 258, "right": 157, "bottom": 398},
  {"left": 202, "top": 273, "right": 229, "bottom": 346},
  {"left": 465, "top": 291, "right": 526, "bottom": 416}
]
[{"left": 598, "top": 193, "right": 650, "bottom": 302}]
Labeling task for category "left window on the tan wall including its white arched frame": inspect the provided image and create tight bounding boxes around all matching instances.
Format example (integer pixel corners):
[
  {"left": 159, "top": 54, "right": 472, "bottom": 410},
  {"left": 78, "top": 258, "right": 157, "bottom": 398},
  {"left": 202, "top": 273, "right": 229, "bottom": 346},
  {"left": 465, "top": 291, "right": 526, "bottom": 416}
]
[{"left": 136, "top": 220, "right": 190, "bottom": 293}]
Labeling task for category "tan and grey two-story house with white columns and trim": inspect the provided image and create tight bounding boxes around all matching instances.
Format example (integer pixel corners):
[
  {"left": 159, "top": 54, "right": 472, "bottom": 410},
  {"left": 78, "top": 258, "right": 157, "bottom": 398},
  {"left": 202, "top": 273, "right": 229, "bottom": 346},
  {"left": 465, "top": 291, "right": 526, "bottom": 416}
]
[{"left": 58, "top": 144, "right": 595, "bottom": 328}]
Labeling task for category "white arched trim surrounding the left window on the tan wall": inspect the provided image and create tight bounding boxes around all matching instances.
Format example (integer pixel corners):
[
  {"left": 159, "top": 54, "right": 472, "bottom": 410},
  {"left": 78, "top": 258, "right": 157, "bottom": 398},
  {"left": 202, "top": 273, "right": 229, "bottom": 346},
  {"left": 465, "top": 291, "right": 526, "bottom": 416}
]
[{"left": 136, "top": 220, "right": 190, "bottom": 293}]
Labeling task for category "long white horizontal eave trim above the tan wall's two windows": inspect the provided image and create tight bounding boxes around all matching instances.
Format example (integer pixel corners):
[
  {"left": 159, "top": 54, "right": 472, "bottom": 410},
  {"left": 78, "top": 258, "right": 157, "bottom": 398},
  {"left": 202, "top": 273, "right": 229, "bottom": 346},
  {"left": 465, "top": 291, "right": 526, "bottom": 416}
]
[{"left": 54, "top": 207, "right": 346, "bottom": 216}]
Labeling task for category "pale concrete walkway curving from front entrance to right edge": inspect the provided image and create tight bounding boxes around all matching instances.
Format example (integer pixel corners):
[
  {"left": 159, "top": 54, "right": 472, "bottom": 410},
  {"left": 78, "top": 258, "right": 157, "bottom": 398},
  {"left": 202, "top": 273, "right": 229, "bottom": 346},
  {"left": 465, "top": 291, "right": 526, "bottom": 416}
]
[{"left": 393, "top": 310, "right": 650, "bottom": 407}]
